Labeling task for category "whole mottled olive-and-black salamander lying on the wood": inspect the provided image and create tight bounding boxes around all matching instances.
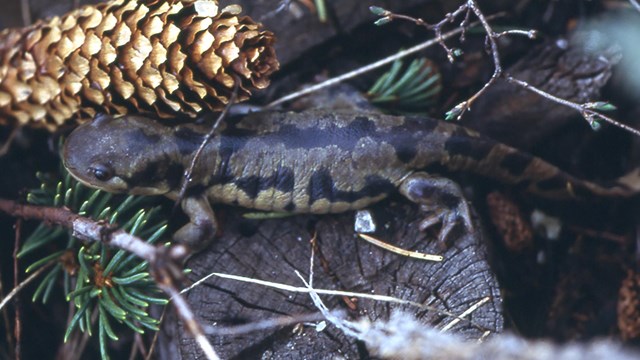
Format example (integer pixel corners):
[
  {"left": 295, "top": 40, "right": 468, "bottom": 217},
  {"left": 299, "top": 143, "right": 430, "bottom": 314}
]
[{"left": 63, "top": 111, "right": 640, "bottom": 246}]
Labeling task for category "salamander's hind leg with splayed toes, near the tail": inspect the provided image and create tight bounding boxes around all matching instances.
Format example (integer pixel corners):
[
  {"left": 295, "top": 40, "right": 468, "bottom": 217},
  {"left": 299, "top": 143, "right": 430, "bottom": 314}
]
[{"left": 399, "top": 172, "right": 473, "bottom": 244}]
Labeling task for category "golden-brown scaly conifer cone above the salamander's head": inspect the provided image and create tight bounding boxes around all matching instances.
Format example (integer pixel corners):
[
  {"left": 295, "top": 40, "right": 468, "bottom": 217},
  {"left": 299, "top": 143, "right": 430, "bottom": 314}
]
[{"left": 0, "top": 0, "right": 279, "bottom": 130}]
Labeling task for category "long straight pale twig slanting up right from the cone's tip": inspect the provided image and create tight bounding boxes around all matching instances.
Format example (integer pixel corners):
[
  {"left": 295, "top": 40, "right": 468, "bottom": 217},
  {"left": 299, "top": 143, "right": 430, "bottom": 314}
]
[{"left": 265, "top": 14, "right": 500, "bottom": 109}]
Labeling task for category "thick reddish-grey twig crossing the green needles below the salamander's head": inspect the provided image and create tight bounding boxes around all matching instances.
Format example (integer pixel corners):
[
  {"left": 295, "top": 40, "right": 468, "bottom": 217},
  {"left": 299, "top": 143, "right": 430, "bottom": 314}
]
[{"left": 0, "top": 199, "right": 219, "bottom": 359}]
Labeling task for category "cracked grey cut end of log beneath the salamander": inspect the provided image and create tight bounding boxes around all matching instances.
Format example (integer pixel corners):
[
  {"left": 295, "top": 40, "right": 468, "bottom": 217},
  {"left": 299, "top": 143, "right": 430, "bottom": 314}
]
[{"left": 159, "top": 202, "right": 503, "bottom": 359}]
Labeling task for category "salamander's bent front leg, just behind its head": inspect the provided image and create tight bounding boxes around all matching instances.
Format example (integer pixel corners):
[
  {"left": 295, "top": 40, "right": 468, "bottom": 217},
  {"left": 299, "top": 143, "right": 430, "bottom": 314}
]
[{"left": 173, "top": 195, "right": 218, "bottom": 252}]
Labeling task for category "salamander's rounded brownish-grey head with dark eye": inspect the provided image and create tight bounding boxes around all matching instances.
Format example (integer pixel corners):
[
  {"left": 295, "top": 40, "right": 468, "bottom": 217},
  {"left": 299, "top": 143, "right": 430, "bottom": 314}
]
[{"left": 62, "top": 115, "right": 171, "bottom": 195}]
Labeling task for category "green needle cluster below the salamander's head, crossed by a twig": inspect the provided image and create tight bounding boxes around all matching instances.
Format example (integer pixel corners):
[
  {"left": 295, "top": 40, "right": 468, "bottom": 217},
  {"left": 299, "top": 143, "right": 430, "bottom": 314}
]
[{"left": 18, "top": 169, "right": 167, "bottom": 359}]
